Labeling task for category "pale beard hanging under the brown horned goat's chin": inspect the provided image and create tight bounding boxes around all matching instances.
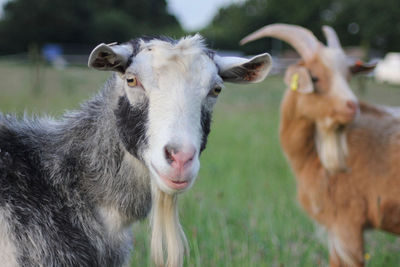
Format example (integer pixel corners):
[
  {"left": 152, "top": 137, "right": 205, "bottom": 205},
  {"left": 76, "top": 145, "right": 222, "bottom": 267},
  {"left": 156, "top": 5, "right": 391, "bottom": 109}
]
[{"left": 316, "top": 125, "right": 348, "bottom": 173}]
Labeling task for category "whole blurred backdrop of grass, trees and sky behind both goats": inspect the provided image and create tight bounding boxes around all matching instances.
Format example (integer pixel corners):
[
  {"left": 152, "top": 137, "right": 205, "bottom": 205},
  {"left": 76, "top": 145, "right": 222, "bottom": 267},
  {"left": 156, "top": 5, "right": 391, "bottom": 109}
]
[{"left": 0, "top": 0, "right": 400, "bottom": 266}]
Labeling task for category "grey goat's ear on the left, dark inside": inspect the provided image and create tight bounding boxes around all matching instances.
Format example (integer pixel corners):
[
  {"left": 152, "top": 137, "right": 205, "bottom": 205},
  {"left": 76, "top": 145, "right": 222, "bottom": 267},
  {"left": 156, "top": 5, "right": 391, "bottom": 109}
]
[{"left": 88, "top": 43, "right": 132, "bottom": 73}]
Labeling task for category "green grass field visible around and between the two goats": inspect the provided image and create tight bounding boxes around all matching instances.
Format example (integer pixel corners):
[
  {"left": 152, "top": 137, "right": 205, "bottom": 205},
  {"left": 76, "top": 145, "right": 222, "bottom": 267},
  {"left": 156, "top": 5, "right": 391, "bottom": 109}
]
[{"left": 0, "top": 62, "right": 400, "bottom": 266}]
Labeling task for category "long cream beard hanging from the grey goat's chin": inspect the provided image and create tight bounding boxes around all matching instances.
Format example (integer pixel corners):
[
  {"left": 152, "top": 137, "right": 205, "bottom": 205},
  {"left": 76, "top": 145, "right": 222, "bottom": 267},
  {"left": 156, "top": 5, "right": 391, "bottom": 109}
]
[{"left": 150, "top": 186, "right": 189, "bottom": 267}]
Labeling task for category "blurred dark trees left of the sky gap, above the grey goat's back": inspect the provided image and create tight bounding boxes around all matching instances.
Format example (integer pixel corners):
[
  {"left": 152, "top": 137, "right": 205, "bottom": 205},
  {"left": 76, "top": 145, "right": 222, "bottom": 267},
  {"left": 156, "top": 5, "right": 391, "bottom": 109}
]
[{"left": 0, "top": 0, "right": 182, "bottom": 54}]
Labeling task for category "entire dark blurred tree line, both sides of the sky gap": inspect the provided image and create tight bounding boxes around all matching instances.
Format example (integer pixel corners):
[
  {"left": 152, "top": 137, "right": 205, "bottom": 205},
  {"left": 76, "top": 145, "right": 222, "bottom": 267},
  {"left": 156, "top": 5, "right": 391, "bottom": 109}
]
[{"left": 0, "top": 0, "right": 400, "bottom": 54}]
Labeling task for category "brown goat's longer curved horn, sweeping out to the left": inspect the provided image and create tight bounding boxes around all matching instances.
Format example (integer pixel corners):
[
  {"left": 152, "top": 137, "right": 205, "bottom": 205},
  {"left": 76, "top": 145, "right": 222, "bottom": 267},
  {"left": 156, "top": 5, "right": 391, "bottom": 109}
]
[{"left": 240, "top": 24, "right": 322, "bottom": 61}]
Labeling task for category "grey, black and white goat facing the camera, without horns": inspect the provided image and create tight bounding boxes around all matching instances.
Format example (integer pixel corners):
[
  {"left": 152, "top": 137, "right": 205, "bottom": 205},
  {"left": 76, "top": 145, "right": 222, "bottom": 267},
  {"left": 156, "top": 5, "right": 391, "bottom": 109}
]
[{"left": 0, "top": 35, "right": 271, "bottom": 266}]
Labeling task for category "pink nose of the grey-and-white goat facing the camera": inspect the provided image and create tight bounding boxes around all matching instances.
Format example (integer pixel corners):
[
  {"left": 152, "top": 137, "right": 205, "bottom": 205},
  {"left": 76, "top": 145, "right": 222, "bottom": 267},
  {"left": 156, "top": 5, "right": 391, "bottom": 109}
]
[{"left": 164, "top": 145, "right": 196, "bottom": 169}]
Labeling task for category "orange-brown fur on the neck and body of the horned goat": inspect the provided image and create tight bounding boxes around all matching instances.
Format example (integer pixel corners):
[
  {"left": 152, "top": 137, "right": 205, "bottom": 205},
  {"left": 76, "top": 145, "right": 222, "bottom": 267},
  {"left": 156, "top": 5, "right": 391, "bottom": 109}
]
[{"left": 280, "top": 76, "right": 400, "bottom": 266}]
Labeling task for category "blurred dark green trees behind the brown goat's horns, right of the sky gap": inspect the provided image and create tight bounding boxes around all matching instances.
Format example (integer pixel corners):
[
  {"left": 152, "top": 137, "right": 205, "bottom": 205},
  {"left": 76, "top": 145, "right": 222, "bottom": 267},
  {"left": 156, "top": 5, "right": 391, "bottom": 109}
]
[{"left": 202, "top": 0, "right": 400, "bottom": 54}]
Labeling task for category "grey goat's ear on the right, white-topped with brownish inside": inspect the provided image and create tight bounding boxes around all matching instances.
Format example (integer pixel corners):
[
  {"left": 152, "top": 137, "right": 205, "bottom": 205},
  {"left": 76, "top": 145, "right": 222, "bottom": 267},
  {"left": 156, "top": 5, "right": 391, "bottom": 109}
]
[{"left": 214, "top": 53, "right": 272, "bottom": 83}]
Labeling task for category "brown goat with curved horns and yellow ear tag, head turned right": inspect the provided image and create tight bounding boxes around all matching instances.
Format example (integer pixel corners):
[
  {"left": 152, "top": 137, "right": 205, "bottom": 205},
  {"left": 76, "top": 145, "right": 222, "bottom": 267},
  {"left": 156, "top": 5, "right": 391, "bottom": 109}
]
[{"left": 242, "top": 24, "right": 400, "bottom": 266}]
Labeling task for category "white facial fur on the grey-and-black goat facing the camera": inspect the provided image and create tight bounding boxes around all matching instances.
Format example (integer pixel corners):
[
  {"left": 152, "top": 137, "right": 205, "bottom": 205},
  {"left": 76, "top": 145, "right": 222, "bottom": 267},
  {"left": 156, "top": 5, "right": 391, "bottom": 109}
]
[{"left": 125, "top": 37, "right": 222, "bottom": 193}]
